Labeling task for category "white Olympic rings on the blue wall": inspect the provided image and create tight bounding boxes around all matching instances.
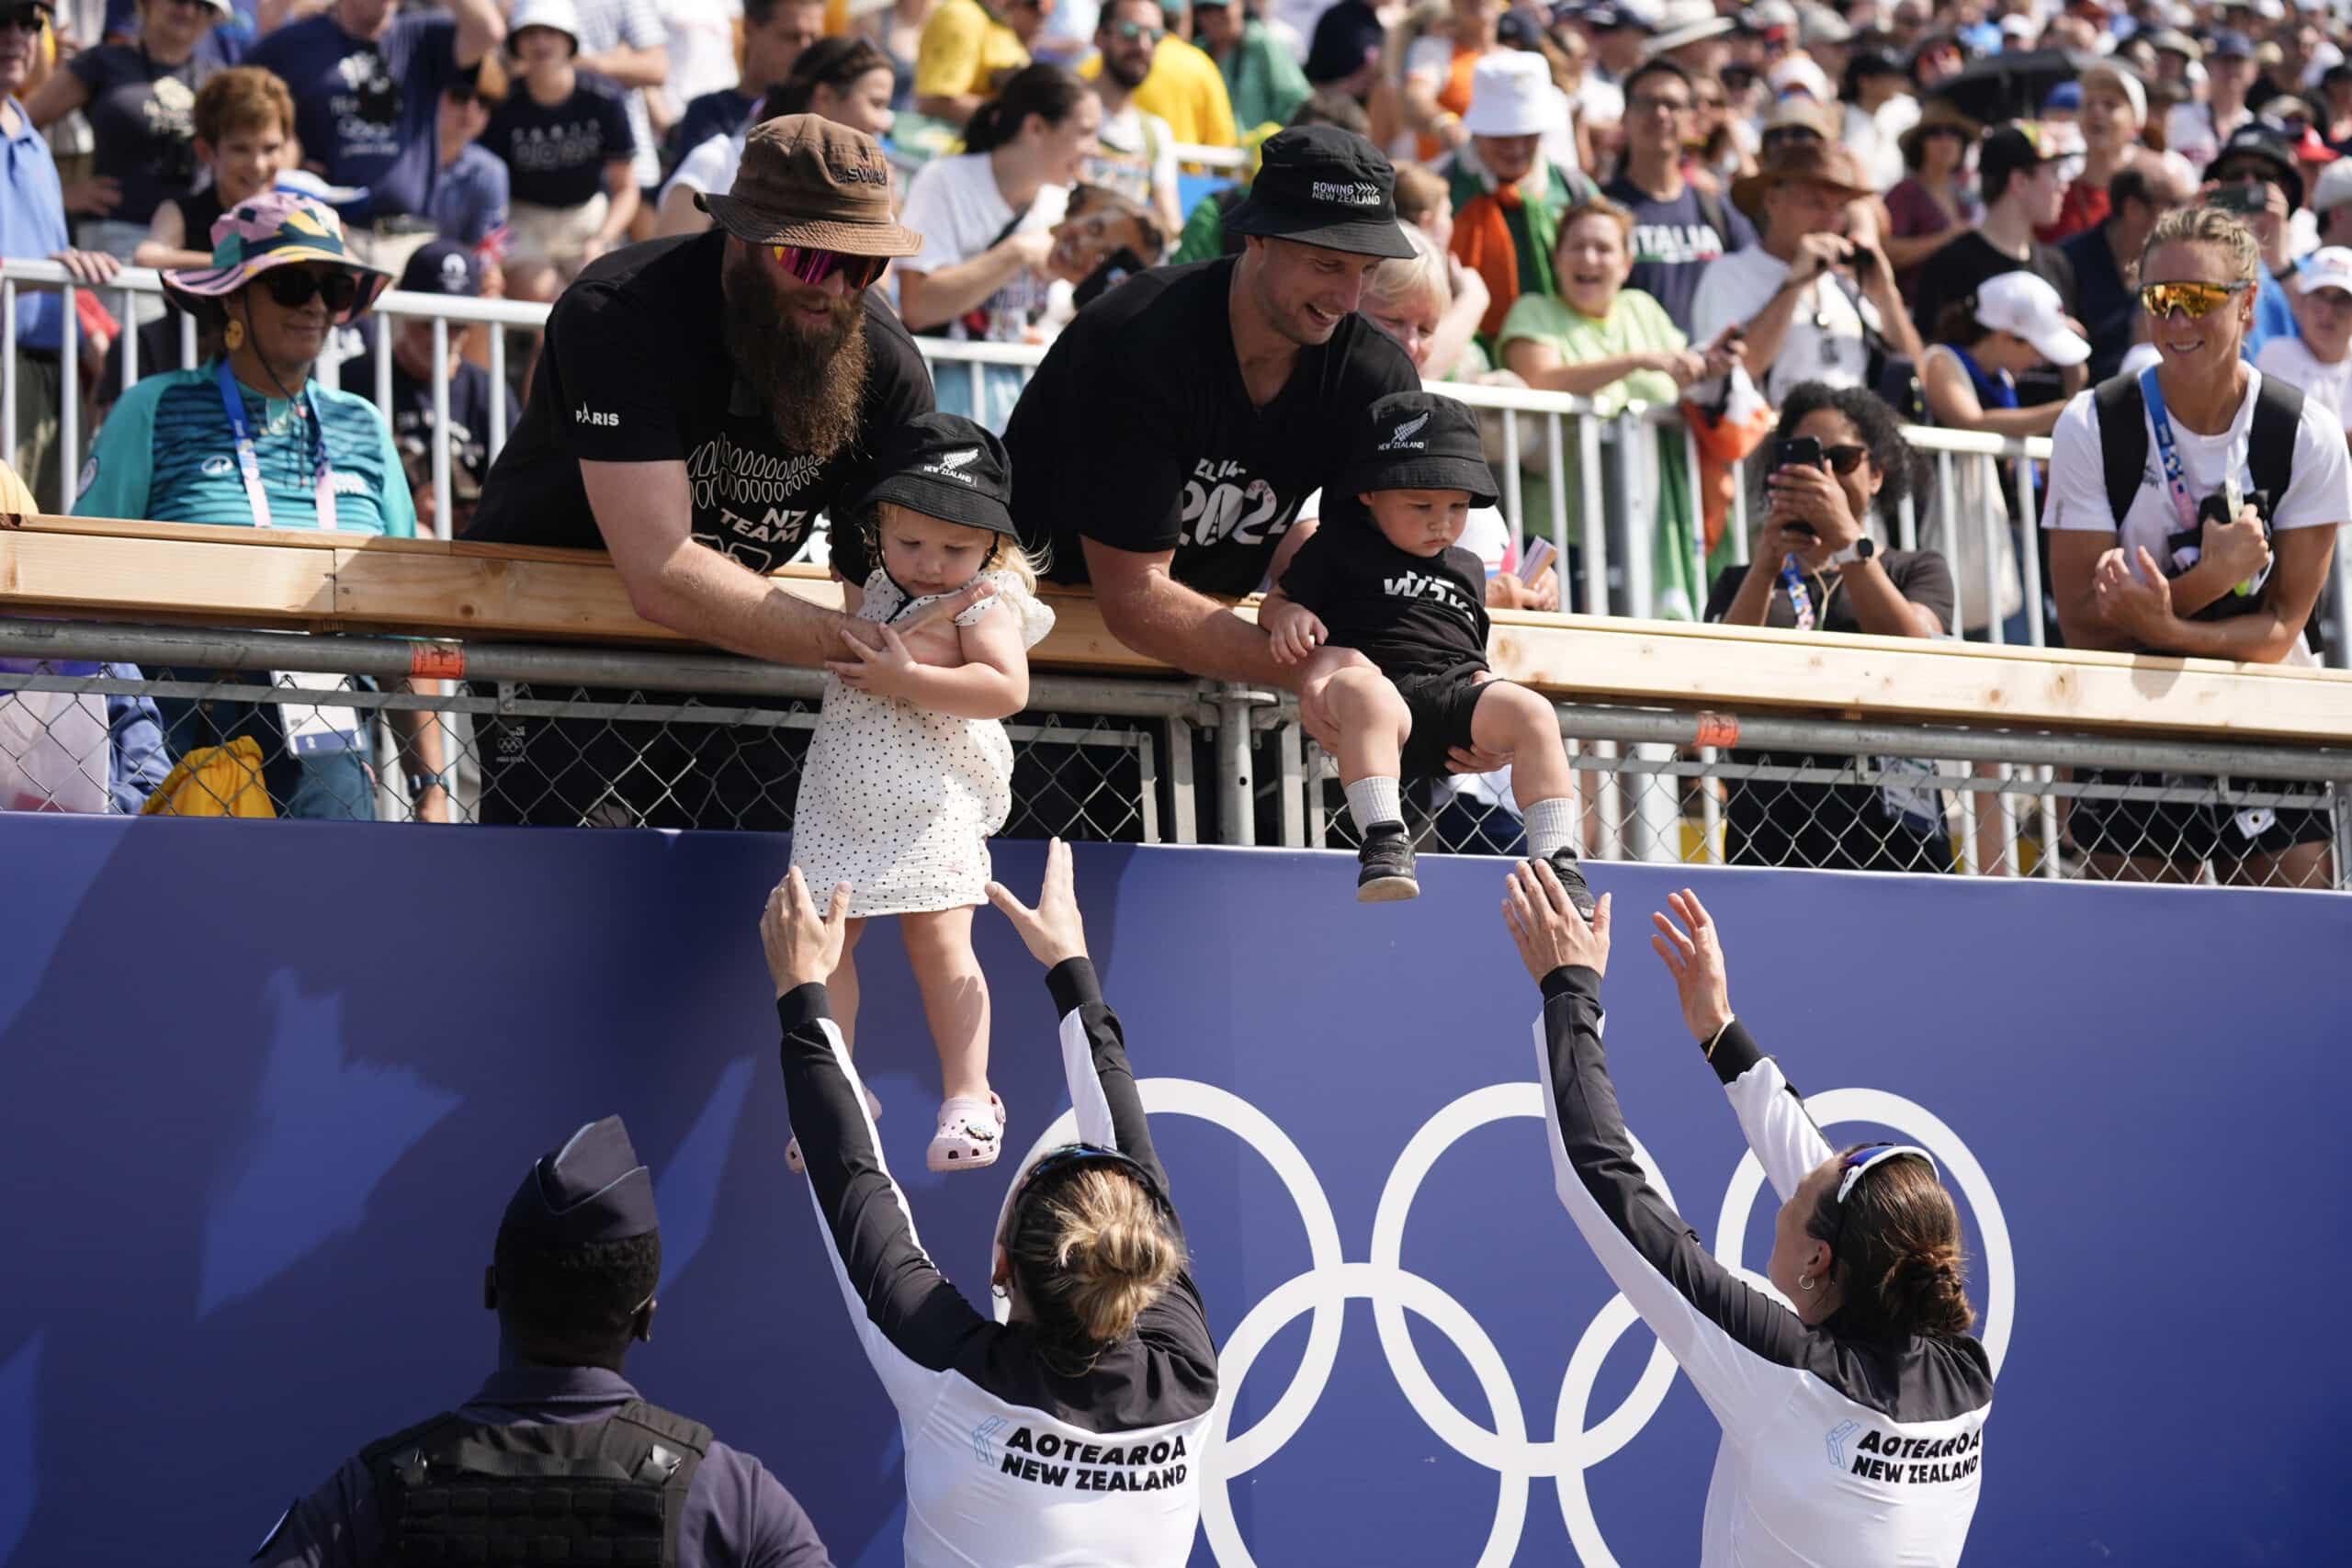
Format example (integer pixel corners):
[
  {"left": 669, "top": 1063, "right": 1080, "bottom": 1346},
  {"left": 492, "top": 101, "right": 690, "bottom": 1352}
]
[{"left": 1000, "top": 1079, "right": 2018, "bottom": 1568}]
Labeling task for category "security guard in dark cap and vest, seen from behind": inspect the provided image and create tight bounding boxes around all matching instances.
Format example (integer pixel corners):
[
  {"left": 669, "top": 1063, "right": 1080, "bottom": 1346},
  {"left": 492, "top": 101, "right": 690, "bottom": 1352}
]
[{"left": 252, "top": 1117, "right": 832, "bottom": 1568}]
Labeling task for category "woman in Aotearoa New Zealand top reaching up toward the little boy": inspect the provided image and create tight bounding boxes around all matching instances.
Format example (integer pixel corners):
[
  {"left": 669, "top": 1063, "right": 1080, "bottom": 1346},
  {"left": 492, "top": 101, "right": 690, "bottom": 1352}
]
[{"left": 1503, "top": 863, "right": 1992, "bottom": 1568}]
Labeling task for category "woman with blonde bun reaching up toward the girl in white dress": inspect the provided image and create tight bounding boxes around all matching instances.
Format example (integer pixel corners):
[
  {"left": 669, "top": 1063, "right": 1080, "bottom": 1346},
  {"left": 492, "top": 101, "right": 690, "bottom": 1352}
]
[{"left": 760, "top": 840, "right": 1216, "bottom": 1568}]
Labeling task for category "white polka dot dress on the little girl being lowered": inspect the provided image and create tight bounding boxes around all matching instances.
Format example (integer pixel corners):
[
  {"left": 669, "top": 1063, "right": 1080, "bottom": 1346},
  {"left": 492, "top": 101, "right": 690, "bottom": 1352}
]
[{"left": 793, "top": 571, "right": 1054, "bottom": 919}]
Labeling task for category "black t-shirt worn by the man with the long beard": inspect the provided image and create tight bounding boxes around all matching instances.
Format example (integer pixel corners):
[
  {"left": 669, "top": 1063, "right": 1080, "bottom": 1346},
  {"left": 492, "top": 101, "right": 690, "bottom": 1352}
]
[{"left": 466, "top": 231, "right": 932, "bottom": 583}]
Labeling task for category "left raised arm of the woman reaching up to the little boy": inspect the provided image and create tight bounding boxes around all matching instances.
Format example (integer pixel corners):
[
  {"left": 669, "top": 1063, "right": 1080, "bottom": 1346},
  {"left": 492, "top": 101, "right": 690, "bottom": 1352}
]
[{"left": 1503, "top": 863, "right": 1809, "bottom": 1434}]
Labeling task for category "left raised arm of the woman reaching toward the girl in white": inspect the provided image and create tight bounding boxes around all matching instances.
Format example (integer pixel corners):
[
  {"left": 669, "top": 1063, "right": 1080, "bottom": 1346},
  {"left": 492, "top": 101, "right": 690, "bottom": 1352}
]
[{"left": 760, "top": 867, "right": 995, "bottom": 1408}]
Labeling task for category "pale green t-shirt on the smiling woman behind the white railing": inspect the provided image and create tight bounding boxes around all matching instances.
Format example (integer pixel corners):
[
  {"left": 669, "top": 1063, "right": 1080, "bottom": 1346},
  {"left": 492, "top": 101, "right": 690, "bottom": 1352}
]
[{"left": 1500, "top": 289, "right": 1705, "bottom": 621}]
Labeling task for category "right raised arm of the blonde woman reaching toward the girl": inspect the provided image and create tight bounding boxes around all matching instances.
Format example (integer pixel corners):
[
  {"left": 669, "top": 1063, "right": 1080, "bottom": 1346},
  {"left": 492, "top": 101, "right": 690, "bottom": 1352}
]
[{"left": 988, "top": 840, "right": 1169, "bottom": 1192}]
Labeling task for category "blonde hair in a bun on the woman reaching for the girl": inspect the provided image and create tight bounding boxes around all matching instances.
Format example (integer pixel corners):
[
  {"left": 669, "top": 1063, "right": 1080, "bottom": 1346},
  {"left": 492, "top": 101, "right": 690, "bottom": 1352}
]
[{"left": 1004, "top": 1166, "right": 1183, "bottom": 1354}]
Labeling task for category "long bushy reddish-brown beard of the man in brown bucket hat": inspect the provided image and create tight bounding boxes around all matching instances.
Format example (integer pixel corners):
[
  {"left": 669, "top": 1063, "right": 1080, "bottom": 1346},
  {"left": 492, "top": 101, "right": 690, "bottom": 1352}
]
[{"left": 724, "top": 259, "right": 865, "bottom": 458}]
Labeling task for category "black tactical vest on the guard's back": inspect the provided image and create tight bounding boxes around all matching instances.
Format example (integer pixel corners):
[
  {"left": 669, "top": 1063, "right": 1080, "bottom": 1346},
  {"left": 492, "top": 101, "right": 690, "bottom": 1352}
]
[{"left": 360, "top": 1399, "right": 710, "bottom": 1568}]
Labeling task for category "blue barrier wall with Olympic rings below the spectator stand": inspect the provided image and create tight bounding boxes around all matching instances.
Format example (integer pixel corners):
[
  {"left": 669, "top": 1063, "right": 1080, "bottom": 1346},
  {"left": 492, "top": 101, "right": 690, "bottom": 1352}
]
[{"left": 0, "top": 816, "right": 2352, "bottom": 1568}]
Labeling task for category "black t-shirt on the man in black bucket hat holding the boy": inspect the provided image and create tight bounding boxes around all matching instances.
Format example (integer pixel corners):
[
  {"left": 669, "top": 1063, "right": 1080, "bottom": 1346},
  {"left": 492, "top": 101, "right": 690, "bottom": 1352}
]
[{"left": 1004, "top": 259, "right": 1420, "bottom": 594}]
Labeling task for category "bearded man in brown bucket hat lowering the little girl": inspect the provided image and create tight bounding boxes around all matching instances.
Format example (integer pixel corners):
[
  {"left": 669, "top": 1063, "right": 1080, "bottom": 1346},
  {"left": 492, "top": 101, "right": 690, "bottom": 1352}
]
[{"left": 466, "top": 115, "right": 971, "bottom": 829}]
